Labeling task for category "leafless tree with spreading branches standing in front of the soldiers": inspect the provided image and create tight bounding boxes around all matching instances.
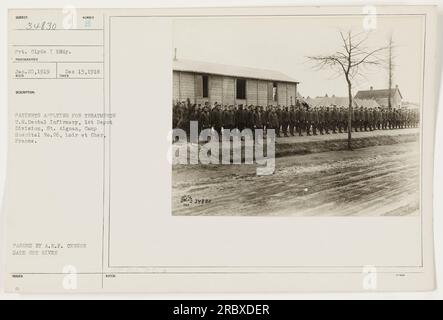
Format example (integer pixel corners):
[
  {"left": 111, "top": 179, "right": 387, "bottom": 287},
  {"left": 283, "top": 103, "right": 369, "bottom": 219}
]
[{"left": 308, "top": 31, "right": 386, "bottom": 150}]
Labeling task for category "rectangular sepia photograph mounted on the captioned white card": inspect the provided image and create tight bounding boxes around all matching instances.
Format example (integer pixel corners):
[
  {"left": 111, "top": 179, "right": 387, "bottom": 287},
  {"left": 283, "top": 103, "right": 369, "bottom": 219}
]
[{"left": 172, "top": 15, "right": 426, "bottom": 216}]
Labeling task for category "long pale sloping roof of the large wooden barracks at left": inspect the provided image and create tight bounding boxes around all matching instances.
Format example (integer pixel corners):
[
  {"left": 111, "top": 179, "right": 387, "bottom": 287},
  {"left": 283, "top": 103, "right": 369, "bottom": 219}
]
[{"left": 173, "top": 59, "right": 298, "bottom": 83}]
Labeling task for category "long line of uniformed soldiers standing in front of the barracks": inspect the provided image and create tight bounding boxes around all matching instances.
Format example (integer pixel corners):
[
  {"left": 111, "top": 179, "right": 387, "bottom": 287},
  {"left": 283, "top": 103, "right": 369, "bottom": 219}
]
[{"left": 173, "top": 99, "right": 420, "bottom": 137}]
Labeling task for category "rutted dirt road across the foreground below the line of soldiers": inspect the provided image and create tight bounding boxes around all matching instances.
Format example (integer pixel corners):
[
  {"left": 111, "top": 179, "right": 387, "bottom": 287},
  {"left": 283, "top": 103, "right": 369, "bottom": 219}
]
[{"left": 172, "top": 142, "right": 420, "bottom": 216}]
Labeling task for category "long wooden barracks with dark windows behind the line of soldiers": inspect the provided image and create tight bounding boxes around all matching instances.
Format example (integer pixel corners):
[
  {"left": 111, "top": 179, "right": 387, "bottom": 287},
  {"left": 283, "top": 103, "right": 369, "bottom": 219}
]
[{"left": 173, "top": 59, "right": 298, "bottom": 106}]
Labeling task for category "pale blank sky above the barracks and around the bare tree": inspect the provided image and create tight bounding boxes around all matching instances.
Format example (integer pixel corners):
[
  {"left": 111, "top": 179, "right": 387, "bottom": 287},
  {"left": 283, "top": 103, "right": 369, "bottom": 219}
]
[{"left": 173, "top": 16, "right": 424, "bottom": 102}]
